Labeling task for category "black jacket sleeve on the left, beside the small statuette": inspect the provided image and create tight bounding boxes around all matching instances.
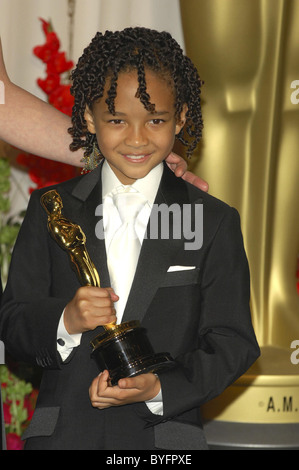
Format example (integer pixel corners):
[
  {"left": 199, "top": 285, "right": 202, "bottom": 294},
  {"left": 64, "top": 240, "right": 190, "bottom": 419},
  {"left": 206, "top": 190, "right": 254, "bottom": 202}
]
[{"left": 0, "top": 191, "right": 67, "bottom": 368}]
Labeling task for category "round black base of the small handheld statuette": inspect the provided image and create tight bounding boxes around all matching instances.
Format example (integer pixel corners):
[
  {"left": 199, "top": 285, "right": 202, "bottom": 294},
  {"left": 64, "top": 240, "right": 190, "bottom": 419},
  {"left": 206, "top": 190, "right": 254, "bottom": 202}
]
[{"left": 91, "top": 321, "right": 174, "bottom": 385}]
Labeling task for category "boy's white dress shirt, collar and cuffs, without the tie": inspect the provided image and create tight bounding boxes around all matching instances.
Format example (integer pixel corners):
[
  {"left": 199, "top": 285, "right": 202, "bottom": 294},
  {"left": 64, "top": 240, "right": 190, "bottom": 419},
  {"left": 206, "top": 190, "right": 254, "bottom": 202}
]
[{"left": 57, "top": 160, "right": 163, "bottom": 414}]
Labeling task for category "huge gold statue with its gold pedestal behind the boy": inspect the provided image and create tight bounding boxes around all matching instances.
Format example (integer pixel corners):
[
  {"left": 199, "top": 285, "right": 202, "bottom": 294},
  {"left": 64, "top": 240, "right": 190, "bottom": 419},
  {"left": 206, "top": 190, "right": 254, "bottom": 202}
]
[{"left": 181, "top": 0, "right": 299, "bottom": 445}]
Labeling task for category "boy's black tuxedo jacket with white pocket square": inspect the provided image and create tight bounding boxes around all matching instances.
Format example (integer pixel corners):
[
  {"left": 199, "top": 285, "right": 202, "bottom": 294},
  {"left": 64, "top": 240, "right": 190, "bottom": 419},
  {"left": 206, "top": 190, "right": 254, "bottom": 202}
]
[{"left": 0, "top": 166, "right": 259, "bottom": 450}]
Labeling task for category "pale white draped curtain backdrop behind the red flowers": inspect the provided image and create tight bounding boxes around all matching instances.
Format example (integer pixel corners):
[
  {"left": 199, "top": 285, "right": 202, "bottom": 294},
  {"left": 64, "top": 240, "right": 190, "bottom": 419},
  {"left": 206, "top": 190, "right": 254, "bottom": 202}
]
[{"left": 0, "top": 0, "right": 184, "bottom": 214}]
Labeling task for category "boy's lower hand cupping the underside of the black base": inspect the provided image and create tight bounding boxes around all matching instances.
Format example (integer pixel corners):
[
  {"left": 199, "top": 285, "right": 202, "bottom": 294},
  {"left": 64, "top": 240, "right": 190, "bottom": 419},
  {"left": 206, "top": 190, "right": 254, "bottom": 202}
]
[{"left": 89, "top": 370, "right": 160, "bottom": 410}]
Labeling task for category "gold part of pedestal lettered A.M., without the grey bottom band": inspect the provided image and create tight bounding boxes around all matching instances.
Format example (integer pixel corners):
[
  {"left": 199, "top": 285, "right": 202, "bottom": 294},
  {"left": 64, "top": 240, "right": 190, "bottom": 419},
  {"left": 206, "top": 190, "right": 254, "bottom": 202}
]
[{"left": 202, "top": 346, "right": 299, "bottom": 424}]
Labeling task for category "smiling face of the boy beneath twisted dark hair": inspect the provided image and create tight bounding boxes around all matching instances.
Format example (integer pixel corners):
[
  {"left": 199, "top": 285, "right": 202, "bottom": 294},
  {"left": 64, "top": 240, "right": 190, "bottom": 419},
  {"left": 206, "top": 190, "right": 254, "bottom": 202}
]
[{"left": 84, "top": 71, "right": 187, "bottom": 184}]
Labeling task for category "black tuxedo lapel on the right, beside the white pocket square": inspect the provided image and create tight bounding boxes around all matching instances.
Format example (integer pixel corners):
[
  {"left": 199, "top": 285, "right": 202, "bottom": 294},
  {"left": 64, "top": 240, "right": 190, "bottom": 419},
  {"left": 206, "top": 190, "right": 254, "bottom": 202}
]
[{"left": 123, "top": 163, "right": 196, "bottom": 321}]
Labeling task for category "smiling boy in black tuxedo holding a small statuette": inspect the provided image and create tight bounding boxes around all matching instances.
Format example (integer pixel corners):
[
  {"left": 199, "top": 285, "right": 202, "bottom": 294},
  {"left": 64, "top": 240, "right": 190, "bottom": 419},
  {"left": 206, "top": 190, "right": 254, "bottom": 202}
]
[{"left": 0, "top": 28, "right": 259, "bottom": 450}]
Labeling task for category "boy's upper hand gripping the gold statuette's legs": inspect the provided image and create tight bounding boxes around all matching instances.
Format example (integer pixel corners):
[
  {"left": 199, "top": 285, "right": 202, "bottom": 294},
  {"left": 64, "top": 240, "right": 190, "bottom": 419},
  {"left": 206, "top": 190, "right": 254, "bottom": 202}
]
[{"left": 64, "top": 286, "right": 119, "bottom": 334}]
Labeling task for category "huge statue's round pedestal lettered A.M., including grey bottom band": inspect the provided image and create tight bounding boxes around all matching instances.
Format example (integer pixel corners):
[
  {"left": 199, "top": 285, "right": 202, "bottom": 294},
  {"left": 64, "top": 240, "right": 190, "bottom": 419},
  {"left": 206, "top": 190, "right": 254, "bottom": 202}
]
[{"left": 202, "top": 346, "right": 299, "bottom": 449}]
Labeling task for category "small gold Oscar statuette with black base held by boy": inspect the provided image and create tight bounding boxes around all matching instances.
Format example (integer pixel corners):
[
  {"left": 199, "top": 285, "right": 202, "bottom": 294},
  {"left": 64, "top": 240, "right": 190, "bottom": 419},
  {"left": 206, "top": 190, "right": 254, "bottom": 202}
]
[{"left": 41, "top": 190, "right": 173, "bottom": 385}]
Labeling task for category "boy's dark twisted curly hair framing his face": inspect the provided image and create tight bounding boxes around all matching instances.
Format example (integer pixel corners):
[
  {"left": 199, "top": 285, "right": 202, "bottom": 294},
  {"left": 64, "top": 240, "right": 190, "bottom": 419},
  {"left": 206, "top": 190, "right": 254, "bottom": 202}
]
[{"left": 69, "top": 27, "right": 203, "bottom": 164}]
